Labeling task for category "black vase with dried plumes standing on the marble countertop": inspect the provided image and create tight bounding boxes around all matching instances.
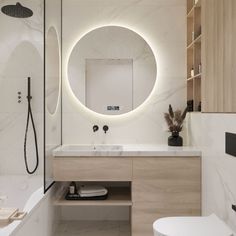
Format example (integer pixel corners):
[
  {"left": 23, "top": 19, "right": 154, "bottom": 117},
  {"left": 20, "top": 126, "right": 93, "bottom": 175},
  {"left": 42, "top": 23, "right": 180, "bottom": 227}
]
[{"left": 164, "top": 105, "right": 188, "bottom": 146}]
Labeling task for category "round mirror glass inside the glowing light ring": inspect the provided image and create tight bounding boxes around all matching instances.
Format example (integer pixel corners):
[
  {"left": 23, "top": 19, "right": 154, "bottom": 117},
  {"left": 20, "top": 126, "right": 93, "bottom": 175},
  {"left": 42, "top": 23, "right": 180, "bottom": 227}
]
[{"left": 68, "top": 26, "right": 157, "bottom": 115}]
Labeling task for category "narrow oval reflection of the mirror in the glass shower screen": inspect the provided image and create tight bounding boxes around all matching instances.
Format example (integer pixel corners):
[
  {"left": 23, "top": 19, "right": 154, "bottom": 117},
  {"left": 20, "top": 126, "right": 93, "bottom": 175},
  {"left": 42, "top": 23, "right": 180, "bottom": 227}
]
[{"left": 46, "top": 27, "right": 60, "bottom": 114}]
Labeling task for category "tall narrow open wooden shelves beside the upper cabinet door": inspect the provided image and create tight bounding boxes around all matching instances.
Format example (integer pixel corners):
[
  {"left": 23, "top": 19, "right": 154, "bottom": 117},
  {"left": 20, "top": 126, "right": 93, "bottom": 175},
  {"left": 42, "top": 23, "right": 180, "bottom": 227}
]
[{"left": 187, "top": 0, "right": 202, "bottom": 111}]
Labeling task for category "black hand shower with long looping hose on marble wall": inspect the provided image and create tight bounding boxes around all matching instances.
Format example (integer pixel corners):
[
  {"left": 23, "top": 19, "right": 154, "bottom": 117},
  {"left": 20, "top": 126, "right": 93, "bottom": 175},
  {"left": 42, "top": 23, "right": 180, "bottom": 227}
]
[{"left": 24, "top": 78, "right": 39, "bottom": 175}]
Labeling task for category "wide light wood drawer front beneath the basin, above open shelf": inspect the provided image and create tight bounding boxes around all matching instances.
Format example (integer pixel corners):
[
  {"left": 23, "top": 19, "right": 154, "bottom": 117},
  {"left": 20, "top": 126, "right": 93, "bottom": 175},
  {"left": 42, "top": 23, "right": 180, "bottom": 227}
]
[{"left": 53, "top": 157, "right": 132, "bottom": 181}]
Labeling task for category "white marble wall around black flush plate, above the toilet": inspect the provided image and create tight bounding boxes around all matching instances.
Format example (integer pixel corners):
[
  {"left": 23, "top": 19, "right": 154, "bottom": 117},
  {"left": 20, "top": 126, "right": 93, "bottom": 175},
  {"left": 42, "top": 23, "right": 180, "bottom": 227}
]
[{"left": 188, "top": 113, "right": 236, "bottom": 232}]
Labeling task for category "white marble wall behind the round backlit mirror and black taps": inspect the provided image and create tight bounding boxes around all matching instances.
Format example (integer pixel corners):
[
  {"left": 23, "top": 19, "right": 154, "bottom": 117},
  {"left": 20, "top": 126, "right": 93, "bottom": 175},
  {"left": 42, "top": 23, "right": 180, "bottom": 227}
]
[{"left": 62, "top": 0, "right": 186, "bottom": 144}]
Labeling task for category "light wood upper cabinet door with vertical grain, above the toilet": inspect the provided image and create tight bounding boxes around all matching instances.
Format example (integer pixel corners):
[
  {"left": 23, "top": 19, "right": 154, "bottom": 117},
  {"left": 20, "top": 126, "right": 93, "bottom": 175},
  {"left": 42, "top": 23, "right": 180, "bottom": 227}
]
[{"left": 202, "top": 0, "right": 236, "bottom": 112}]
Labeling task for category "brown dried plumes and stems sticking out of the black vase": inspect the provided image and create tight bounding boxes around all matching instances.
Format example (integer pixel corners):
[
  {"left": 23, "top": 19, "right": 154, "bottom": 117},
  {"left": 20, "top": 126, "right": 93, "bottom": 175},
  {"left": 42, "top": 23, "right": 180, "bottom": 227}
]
[{"left": 164, "top": 105, "right": 188, "bottom": 134}]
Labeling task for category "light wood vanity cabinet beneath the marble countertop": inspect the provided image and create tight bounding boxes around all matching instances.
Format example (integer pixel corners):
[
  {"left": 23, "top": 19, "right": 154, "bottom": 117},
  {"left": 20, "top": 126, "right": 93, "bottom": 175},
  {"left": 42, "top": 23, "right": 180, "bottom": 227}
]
[{"left": 53, "top": 157, "right": 201, "bottom": 236}]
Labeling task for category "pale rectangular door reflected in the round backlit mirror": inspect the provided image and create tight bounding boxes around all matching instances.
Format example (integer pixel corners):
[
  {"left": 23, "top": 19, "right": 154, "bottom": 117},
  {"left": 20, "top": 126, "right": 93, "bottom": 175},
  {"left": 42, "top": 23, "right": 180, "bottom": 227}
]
[{"left": 85, "top": 59, "right": 133, "bottom": 115}]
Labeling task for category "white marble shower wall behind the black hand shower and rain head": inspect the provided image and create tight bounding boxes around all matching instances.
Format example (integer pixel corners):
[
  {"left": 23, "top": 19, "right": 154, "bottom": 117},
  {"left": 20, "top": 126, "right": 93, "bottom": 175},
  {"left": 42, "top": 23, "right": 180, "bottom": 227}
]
[{"left": 0, "top": 0, "right": 43, "bottom": 174}]
